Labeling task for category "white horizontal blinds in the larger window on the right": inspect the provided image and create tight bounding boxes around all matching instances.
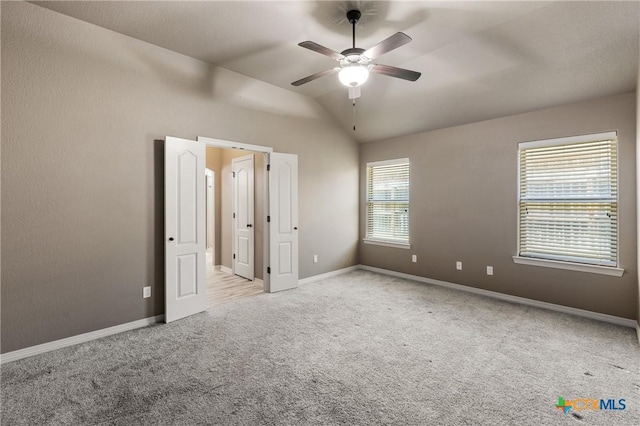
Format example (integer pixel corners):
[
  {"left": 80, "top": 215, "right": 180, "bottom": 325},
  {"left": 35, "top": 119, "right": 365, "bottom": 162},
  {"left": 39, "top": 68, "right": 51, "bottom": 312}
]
[{"left": 519, "top": 133, "right": 618, "bottom": 267}]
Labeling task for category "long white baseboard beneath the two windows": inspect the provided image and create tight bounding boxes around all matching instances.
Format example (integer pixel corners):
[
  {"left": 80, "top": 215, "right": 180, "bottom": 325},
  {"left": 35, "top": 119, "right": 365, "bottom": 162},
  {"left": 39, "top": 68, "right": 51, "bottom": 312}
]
[{"left": 360, "top": 265, "right": 640, "bottom": 330}]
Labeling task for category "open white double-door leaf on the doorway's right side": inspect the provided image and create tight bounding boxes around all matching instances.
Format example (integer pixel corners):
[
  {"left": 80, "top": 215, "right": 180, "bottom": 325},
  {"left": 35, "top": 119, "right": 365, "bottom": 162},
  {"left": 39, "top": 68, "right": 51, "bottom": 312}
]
[{"left": 269, "top": 153, "right": 298, "bottom": 292}]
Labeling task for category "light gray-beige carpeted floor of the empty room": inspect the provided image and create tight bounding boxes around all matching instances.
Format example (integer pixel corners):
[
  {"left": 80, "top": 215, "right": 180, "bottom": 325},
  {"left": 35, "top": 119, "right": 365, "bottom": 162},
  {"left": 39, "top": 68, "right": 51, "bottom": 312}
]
[{"left": 2, "top": 271, "right": 640, "bottom": 425}]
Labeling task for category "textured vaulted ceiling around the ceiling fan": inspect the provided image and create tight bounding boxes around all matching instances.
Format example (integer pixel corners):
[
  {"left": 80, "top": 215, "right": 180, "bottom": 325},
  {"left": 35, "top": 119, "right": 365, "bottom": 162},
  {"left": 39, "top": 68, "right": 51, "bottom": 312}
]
[{"left": 28, "top": 1, "right": 640, "bottom": 142}]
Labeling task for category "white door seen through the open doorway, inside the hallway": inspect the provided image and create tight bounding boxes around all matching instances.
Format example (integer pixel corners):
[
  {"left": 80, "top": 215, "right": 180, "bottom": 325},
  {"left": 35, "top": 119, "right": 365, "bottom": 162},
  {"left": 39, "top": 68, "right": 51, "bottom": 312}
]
[{"left": 231, "top": 155, "right": 254, "bottom": 280}]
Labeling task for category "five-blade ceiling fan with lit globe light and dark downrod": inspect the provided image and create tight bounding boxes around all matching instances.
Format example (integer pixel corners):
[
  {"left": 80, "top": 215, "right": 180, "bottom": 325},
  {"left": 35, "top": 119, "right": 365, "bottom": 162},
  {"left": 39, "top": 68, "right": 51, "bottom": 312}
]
[{"left": 291, "top": 10, "right": 421, "bottom": 99}]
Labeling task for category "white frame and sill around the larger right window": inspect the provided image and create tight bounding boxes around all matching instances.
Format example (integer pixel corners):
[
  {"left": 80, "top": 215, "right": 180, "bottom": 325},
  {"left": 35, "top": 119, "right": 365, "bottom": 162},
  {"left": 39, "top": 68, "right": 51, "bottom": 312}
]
[{"left": 513, "top": 131, "right": 624, "bottom": 277}]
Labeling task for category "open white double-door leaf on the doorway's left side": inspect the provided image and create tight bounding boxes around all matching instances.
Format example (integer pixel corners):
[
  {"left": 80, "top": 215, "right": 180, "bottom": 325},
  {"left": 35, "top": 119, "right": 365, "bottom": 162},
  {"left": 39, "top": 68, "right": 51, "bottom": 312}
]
[{"left": 164, "top": 137, "right": 207, "bottom": 322}]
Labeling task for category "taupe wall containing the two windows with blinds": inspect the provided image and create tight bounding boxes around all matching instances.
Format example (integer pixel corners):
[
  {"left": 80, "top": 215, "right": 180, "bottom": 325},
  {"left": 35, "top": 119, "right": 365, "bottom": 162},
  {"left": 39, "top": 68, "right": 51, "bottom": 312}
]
[{"left": 360, "top": 93, "right": 638, "bottom": 318}]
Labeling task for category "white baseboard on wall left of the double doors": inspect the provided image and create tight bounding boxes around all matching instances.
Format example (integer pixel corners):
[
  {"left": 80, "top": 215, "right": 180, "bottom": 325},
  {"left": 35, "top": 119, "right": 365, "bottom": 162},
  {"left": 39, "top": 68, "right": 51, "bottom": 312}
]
[{"left": 0, "top": 315, "right": 164, "bottom": 364}]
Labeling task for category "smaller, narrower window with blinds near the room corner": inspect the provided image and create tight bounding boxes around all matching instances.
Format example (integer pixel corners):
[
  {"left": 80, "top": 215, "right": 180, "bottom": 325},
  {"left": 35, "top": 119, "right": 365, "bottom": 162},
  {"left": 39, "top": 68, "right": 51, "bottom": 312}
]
[{"left": 365, "top": 158, "right": 409, "bottom": 248}]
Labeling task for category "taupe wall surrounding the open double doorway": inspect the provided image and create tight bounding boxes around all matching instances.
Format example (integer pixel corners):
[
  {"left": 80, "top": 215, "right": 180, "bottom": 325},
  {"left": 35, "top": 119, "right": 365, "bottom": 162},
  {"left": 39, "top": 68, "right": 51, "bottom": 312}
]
[{"left": 1, "top": 2, "right": 358, "bottom": 352}]
